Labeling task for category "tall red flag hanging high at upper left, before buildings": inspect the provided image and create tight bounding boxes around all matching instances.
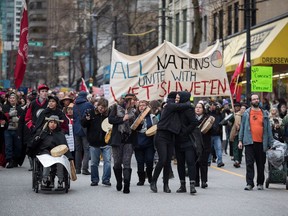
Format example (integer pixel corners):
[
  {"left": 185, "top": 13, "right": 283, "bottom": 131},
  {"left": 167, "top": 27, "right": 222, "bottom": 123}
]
[{"left": 14, "top": 7, "right": 28, "bottom": 89}]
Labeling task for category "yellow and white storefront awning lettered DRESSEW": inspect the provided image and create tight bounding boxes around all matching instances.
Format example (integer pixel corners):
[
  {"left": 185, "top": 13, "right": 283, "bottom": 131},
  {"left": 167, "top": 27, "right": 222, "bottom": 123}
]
[{"left": 224, "top": 17, "right": 288, "bottom": 72}]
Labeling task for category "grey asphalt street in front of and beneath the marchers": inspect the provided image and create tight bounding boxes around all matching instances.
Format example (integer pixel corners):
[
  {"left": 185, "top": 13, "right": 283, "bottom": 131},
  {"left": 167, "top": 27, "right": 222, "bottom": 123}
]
[{"left": 0, "top": 155, "right": 288, "bottom": 216}]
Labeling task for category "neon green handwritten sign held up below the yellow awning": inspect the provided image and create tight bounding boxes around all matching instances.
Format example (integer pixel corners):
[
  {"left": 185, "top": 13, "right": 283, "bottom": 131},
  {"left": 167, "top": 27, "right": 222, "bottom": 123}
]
[{"left": 251, "top": 66, "right": 273, "bottom": 92}]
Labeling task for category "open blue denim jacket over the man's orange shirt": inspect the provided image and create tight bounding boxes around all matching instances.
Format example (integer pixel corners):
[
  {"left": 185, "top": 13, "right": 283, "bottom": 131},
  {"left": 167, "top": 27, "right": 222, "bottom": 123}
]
[{"left": 239, "top": 108, "right": 274, "bottom": 151}]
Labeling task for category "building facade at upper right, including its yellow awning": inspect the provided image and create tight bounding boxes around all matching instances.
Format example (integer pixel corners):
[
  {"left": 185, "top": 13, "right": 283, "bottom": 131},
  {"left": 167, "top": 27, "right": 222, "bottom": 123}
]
[{"left": 163, "top": 0, "right": 288, "bottom": 99}]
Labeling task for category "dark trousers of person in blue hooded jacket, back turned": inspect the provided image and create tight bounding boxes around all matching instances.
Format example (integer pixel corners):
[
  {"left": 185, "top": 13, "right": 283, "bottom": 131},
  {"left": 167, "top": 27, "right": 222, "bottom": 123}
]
[{"left": 74, "top": 136, "right": 90, "bottom": 170}]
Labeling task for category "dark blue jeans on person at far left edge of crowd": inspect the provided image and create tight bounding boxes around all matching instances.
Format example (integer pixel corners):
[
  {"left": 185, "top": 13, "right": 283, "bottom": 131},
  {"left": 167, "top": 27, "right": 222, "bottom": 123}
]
[{"left": 4, "top": 130, "right": 21, "bottom": 161}]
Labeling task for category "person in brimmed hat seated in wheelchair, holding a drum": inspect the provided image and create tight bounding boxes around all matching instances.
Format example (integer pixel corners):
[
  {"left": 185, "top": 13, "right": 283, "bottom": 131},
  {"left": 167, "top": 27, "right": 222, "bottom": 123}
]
[{"left": 27, "top": 115, "right": 73, "bottom": 189}]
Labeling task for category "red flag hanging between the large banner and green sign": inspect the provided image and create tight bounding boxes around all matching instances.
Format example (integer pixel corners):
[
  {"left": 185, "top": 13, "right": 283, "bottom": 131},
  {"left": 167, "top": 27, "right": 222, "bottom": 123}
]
[{"left": 230, "top": 52, "right": 245, "bottom": 102}]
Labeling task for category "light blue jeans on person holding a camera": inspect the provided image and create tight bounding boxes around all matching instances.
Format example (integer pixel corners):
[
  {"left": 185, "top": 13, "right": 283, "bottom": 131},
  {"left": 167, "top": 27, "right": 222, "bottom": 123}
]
[{"left": 89, "top": 146, "right": 111, "bottom": 183}]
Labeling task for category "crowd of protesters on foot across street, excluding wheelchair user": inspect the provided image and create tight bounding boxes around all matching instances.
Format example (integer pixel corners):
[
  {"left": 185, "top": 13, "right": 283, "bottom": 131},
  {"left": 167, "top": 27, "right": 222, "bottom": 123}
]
[{"left": 0, "top": 84, "right": 288, "bottom": 194}]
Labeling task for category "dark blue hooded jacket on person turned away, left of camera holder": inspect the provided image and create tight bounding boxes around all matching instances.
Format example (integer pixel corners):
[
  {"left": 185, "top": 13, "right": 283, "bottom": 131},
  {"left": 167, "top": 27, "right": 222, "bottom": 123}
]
[{"left": 73, "top": 96, "right": 95, "bottom": 137}]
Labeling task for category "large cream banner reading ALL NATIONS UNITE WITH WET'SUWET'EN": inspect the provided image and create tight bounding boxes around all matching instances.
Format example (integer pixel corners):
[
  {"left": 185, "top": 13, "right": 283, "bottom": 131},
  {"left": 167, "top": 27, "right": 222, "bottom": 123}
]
[{"left": 109, "top": 41, "right": 231, "bottom": 103}]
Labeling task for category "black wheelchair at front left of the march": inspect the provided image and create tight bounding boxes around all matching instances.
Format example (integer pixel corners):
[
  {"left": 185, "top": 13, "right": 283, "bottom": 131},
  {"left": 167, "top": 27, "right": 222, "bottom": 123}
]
[{"left": 32, "top": 157, "right": 70, "bottom": 193}]
